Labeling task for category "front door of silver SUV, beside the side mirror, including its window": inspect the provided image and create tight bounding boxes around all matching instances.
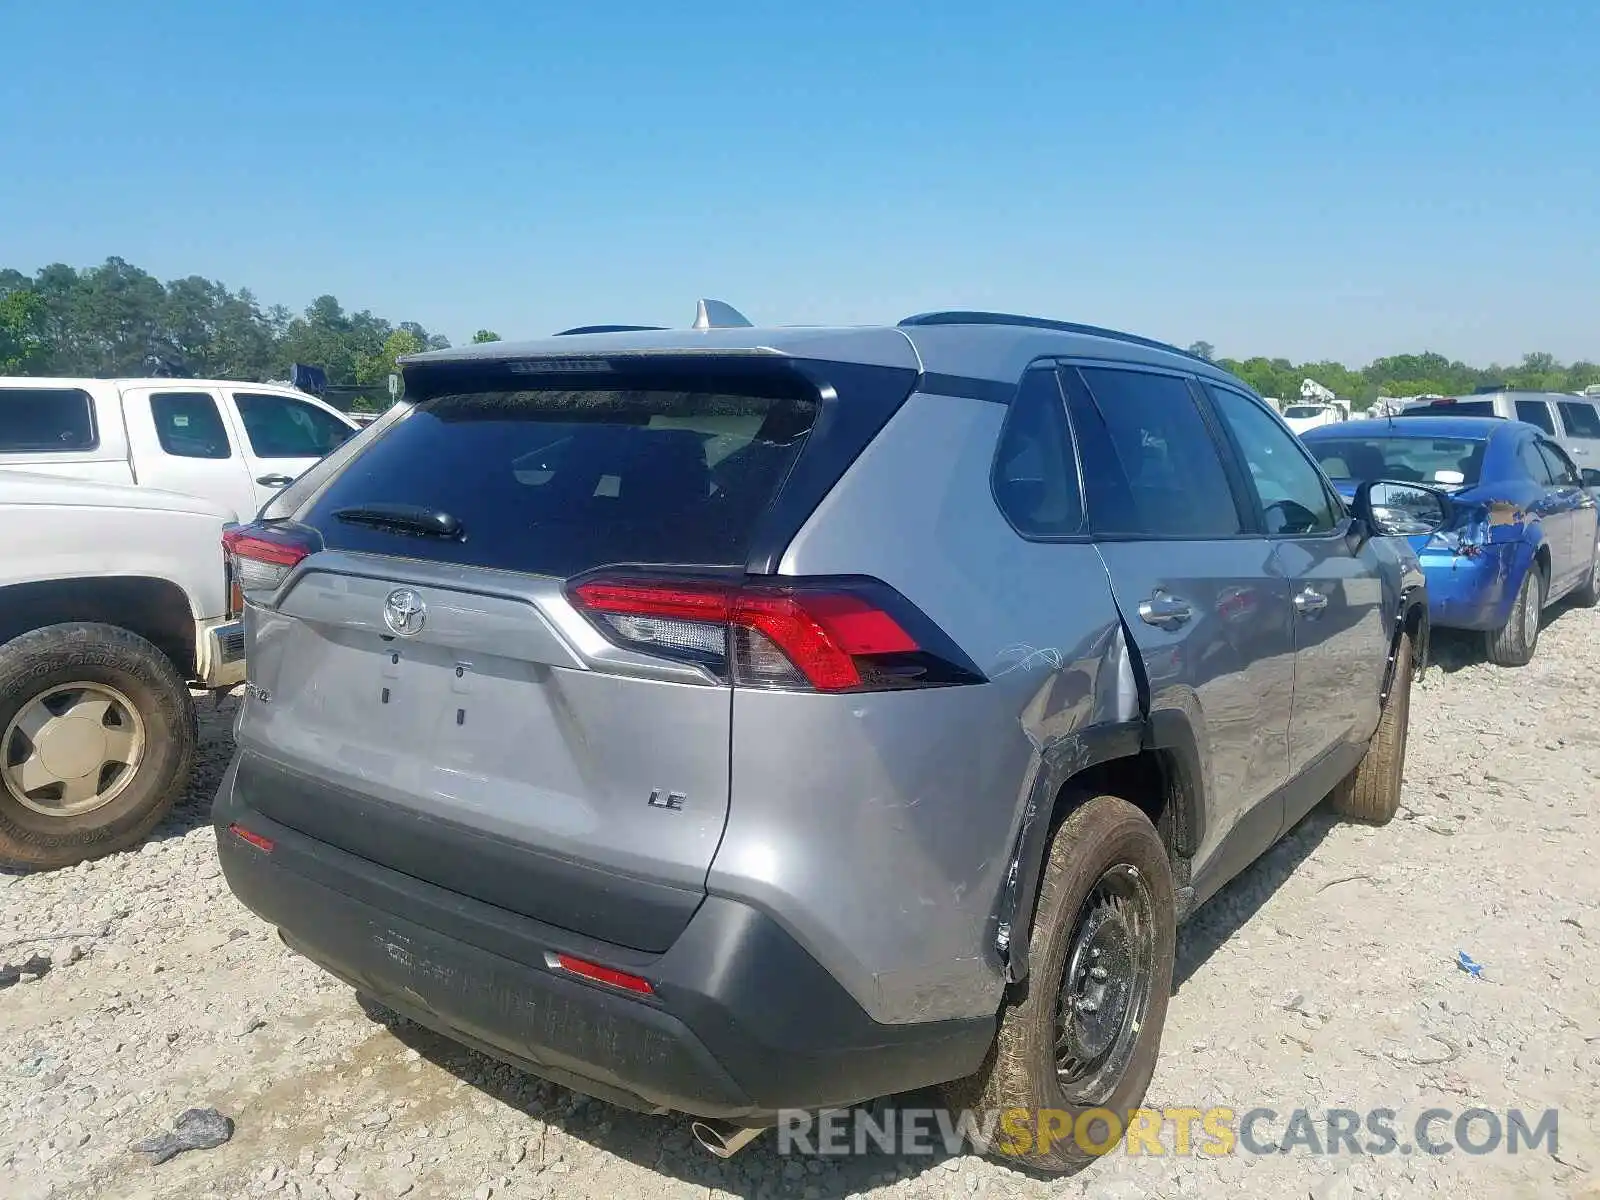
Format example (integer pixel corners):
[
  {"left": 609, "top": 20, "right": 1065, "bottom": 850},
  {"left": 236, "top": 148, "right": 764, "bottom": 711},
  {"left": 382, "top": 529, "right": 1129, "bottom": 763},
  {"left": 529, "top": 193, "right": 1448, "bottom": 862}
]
[{"left": 1205, "top": 382, "right": 1389, "bottom": 790}]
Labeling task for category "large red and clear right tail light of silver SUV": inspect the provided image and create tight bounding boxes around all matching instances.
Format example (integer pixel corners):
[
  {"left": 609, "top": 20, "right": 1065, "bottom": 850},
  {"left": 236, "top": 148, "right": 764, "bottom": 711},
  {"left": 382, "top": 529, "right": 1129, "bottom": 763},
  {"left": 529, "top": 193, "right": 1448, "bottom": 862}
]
[{"left": 570, "top": 576, "right": 982, "bottom": 691}]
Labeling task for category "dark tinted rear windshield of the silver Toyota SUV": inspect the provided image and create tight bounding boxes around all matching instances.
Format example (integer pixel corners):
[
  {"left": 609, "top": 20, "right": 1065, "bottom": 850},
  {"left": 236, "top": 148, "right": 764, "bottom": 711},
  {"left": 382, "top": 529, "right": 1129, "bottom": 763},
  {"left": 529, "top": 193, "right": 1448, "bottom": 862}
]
[{"left": 302, "top": 387, "right": 816, "bottom": 576}]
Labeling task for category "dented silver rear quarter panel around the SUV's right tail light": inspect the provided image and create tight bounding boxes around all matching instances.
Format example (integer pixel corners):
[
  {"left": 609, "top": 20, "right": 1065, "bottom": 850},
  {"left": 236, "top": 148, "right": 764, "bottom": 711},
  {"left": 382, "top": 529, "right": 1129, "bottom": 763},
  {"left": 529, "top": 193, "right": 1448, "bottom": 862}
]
[{"left": 707, "top": 394, "right": 1138, "bottom": 1022}]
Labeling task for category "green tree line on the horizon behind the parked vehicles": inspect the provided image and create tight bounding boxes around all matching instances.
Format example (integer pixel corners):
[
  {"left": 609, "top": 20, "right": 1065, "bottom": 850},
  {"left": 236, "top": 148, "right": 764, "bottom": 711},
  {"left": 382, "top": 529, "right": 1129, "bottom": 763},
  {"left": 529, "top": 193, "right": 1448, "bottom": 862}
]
[{"left": 0, "top": 258, "right": 1600, "bottom": 408}]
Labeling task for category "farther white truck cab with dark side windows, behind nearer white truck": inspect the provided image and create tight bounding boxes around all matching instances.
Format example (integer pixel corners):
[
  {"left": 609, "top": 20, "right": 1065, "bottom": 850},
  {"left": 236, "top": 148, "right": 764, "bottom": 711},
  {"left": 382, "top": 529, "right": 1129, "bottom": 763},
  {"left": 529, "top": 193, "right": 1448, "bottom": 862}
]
[{"left": 0, "top": 376, "right": 357, "bottom": 522}]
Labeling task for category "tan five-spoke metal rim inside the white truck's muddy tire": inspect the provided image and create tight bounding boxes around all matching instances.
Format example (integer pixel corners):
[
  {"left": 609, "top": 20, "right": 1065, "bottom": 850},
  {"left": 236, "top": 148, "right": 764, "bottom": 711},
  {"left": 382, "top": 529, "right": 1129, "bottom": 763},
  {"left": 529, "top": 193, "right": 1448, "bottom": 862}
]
[{"left": 0, "top": 682, "right": 146, "bottom": 816}]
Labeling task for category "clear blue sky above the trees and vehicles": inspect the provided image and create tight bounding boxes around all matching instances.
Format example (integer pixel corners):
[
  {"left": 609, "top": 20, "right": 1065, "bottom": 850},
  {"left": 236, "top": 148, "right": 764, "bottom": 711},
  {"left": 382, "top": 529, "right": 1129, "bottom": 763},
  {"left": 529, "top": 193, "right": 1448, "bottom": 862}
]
[{"left": 0, "top": 0, "right": 1600, "bottom": 363}]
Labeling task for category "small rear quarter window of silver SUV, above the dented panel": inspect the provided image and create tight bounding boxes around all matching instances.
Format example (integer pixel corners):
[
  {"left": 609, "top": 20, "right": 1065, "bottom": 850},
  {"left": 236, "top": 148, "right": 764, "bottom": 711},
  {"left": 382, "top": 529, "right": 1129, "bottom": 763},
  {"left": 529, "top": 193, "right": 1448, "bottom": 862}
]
[{"left": 994, "top": 368, "right": 1083, "bottom": 538}]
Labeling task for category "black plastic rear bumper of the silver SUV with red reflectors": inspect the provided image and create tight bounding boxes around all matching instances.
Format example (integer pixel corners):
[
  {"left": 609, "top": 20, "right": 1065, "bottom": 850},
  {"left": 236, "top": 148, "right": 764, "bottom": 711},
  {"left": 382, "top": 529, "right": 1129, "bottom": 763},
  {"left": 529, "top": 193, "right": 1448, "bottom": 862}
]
[{"left": 214, "top": 760, "right": 995, "bottom": 1125}]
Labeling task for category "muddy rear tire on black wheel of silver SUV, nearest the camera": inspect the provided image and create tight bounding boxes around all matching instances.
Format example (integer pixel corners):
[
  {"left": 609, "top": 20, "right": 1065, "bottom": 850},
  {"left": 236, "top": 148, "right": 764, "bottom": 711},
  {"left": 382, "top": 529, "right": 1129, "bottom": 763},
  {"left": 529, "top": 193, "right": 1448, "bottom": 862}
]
[{"left": 944, "top": 795, "right": 1178, "bottom": 1173}]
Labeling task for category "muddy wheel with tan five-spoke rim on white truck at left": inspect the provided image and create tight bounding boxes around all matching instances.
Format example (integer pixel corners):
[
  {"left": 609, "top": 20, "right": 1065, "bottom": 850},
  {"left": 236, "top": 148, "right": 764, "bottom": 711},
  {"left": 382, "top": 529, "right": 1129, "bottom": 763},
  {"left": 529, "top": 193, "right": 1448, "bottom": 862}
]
[{"left": 0, "top": 622, "right": 197, "bottom": 867}]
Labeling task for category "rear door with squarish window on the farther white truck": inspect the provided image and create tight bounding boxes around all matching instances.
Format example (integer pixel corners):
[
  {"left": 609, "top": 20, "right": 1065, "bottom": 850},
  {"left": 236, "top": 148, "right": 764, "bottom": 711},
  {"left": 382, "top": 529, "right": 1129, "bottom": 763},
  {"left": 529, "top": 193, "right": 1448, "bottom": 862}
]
[{"left": 122, "top": 381, "right": 261, "bottom": 520}]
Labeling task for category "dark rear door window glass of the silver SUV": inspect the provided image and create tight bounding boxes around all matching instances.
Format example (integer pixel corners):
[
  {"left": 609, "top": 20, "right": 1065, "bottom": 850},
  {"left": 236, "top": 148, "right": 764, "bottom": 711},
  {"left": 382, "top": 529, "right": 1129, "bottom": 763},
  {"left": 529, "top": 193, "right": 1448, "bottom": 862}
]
[{"left": 1064, "top": 366, "right": 1245, "bottom": 538}]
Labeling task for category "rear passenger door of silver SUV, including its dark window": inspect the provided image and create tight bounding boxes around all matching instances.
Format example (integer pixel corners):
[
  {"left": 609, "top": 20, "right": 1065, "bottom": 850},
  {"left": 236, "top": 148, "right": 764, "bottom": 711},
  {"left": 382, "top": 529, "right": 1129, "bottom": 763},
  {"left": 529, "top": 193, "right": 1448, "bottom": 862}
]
[{"left": 1061, "top": 363, "right": 1294, "bottom": 898}]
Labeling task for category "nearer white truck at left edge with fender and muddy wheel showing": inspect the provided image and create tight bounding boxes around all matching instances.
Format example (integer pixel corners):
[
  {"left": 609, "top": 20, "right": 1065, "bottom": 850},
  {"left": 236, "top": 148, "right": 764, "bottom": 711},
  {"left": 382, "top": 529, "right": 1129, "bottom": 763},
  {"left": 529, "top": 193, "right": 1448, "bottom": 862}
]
[{"left": 0, "top": 473, "right": 245, "bottom": 867}]
